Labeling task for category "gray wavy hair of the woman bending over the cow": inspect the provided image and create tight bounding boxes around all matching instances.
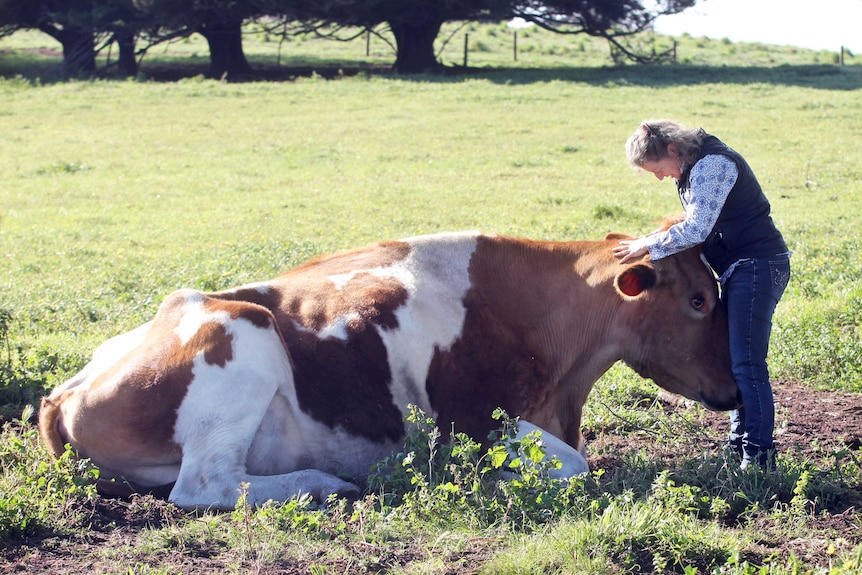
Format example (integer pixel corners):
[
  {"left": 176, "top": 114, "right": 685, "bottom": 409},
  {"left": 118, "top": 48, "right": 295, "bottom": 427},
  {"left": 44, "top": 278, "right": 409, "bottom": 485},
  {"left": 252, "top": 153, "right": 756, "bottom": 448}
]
[{"left": 626, "top": 120, "right": 706, "bottom": 168}]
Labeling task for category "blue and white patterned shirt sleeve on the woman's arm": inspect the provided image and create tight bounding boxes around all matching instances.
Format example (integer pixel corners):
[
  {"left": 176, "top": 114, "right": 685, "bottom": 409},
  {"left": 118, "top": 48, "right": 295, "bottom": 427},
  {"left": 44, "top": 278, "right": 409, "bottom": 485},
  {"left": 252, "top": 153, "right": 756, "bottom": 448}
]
[{"left": 646, "top": 154, "right": 739, "bottom": 260}]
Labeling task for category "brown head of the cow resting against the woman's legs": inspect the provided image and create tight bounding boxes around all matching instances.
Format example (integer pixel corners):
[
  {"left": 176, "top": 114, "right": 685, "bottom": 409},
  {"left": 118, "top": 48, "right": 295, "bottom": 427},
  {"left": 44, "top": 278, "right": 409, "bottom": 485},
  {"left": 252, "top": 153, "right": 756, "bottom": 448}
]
[{"left": 614, "top": 248, "right": 740, "bottom": 411}]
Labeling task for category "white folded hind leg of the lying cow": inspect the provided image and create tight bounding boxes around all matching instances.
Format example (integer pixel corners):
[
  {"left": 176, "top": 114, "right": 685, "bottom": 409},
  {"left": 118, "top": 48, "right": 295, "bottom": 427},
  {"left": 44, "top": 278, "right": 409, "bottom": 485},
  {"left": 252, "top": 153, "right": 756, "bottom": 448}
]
[{"left": 169, "top": 302, "right": 359, "bottom": 509}]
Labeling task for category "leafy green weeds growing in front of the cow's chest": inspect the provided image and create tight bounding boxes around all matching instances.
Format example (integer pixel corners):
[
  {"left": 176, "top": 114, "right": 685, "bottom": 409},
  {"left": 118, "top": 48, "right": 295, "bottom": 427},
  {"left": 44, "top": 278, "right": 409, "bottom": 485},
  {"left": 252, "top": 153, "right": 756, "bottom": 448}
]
[{"left": 369, "top": 407, "right": 586, "bottom": 531}]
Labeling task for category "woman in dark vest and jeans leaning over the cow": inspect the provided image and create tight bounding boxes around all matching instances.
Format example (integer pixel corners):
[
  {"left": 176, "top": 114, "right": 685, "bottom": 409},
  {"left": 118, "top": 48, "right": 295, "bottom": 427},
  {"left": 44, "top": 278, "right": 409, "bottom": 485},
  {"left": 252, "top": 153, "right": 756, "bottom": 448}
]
[{"left": 614, "top": 120, "right": 790, "bottom": 468}]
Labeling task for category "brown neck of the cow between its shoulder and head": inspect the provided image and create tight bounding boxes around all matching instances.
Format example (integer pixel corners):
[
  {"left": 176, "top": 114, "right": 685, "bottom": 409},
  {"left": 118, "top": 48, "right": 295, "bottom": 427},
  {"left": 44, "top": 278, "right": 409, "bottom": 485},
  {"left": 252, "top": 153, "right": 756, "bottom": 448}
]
[{"left": 472, "top": 238, "right": 621, "bottom": 446}]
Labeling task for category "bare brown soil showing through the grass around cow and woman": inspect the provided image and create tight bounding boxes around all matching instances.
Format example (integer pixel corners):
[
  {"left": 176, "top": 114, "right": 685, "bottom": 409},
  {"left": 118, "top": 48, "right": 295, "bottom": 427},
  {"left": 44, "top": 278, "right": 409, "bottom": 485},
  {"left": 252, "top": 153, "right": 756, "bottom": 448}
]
[{"left": 0, "top": 382, "right": 862, "bottom": 575}]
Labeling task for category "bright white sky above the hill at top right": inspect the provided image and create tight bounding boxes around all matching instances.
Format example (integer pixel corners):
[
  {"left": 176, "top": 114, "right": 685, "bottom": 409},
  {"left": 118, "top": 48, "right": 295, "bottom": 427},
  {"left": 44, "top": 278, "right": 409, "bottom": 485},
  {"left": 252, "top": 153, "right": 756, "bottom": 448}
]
[{"left": 655, "top": 0, "right": 862, "bottom": 54}]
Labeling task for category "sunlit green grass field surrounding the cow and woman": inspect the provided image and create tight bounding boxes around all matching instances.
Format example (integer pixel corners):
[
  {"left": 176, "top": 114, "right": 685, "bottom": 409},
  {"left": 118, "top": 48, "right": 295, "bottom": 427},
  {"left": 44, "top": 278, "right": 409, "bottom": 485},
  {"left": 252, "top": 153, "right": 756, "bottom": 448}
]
[{"left": 0, "top": 21, "right": 862, "bottom": 574}]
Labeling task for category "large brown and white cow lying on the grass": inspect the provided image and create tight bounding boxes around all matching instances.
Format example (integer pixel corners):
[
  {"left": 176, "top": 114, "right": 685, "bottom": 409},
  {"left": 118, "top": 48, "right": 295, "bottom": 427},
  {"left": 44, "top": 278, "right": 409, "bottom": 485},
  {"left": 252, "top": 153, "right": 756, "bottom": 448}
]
[{"left": 40, "top": 227, "right": 738, "bottom": 508}]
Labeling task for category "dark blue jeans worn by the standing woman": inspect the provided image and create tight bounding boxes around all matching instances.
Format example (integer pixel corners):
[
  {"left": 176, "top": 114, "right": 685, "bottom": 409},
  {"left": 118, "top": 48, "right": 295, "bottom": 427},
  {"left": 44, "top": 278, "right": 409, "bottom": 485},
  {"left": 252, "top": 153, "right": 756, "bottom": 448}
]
[{"left": 721, "top": 254, "right": 790, "bottom": 465}]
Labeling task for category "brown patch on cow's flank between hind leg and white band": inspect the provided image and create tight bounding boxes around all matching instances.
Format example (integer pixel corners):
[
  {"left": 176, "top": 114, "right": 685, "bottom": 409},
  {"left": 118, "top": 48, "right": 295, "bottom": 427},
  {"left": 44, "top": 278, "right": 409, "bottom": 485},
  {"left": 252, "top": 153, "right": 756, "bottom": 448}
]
[{"left": 269, "top": 242, "right": 410, "bottom": 441}]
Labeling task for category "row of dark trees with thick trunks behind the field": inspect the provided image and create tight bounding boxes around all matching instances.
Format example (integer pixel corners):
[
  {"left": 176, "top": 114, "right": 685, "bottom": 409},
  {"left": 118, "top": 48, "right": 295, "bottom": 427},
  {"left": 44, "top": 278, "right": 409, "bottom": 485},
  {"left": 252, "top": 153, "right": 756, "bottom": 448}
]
[{"left": 0, "top": 0, "right": 695, "bottom": 77}]
